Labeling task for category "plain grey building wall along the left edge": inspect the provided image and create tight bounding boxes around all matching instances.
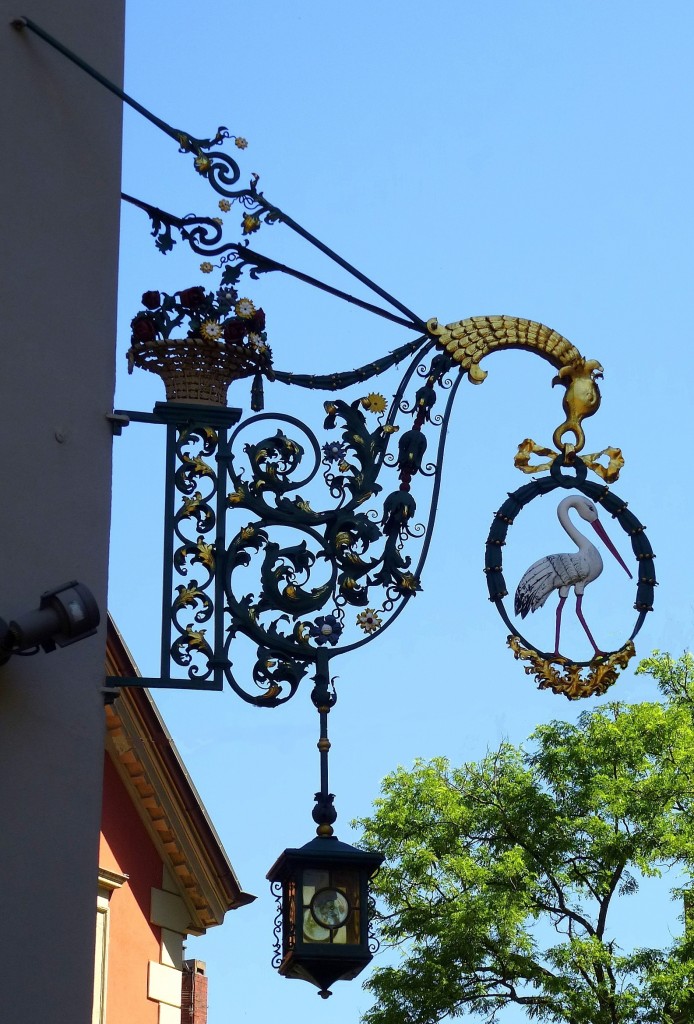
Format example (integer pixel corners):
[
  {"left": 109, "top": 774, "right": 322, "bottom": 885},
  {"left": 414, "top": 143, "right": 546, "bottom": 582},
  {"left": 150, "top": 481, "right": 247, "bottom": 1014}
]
[{"left": 0, "top": 0, "right": 124, "bottom": 1024}]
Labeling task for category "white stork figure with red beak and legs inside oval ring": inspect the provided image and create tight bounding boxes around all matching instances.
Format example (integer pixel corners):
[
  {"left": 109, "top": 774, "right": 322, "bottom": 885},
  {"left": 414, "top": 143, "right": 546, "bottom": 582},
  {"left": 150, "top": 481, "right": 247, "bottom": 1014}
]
[{"left": 514, "top": 495, "right": 632, "bottom": 657}]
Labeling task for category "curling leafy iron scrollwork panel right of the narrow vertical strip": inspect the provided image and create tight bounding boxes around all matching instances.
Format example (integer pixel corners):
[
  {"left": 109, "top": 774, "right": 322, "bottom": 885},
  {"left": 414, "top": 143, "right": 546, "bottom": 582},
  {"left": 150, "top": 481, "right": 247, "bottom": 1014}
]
[{"left": 214, "top": 344, "right": 462, "bottom": 707}]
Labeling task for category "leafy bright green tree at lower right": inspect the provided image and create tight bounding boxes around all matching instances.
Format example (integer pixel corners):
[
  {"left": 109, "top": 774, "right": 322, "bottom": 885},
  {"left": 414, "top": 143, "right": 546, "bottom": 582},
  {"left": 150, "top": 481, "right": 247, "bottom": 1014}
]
[{"left": 358, "top": 651, "right": 694, "bottom": 1024}]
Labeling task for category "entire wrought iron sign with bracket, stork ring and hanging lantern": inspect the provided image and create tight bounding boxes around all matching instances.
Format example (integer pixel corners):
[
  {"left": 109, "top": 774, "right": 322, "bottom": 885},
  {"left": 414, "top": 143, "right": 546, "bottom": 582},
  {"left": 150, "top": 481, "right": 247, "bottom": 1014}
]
[{"left": 18, "top": 18, "right": 655, "bottom": 994}]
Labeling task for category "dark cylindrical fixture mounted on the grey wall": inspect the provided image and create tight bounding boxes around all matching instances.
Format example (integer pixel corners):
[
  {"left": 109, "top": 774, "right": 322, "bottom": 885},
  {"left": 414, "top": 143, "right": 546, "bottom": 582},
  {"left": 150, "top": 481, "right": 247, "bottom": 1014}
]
[{"left": 0, "top": 580, "right": 101, "bottom": 665}]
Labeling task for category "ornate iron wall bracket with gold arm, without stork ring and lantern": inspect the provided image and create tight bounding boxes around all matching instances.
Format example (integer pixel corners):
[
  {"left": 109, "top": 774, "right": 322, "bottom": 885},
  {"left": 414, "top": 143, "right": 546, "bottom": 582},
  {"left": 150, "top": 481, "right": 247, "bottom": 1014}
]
[{"left": 20, "top": 16, "right": 654, "bottom": 708}]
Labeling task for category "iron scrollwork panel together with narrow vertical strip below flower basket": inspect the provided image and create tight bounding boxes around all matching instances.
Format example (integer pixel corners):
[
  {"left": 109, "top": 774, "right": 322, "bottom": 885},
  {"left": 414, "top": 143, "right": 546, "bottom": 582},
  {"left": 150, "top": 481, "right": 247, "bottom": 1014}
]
[{"left": 138, "top": 341, "right": 461, "bottom": 708}]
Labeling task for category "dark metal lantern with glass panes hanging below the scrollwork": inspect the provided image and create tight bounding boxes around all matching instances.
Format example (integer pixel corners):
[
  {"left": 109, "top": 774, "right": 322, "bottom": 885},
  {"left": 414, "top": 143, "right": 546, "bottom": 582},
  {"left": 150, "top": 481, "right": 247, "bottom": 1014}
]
[{"left": 267, "top": 836, "right": 383, "bottom": 999}]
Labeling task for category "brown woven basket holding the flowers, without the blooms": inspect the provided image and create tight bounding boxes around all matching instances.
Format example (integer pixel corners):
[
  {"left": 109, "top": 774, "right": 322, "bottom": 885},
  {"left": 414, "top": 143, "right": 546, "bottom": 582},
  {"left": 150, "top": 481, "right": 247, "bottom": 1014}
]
[{"left": 127, "top": 338, "right": 260, "bottom": 406}]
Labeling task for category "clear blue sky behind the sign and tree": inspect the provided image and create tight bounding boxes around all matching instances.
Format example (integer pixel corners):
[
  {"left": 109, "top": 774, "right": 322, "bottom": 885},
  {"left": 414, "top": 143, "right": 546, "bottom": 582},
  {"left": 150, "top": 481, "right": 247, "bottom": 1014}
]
[{"left": 111, "top": 0, "right": 694, "bottom": 1024}]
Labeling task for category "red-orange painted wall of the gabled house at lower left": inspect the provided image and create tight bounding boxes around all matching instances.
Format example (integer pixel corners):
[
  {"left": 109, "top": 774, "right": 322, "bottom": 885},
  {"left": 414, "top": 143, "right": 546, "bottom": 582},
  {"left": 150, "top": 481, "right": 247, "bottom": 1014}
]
[{"left": 99, "top": 754, "right": 162, "bottom": 1024}]
